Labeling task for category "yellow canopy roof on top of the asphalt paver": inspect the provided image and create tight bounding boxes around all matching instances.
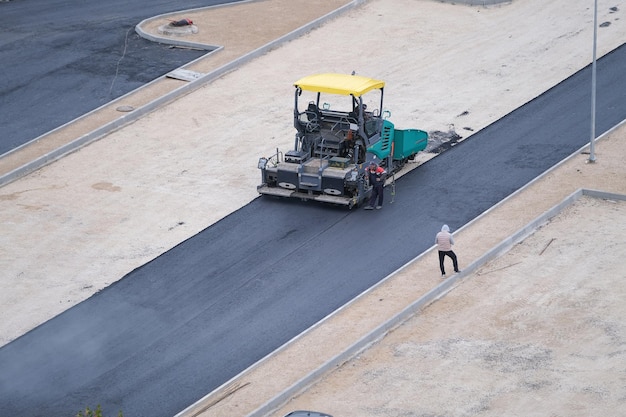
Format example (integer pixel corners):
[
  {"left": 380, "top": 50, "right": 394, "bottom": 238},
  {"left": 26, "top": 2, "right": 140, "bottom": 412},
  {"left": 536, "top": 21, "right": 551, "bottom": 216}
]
[{"left": 294, "top": 74, "right": 385, "bottom": 97}]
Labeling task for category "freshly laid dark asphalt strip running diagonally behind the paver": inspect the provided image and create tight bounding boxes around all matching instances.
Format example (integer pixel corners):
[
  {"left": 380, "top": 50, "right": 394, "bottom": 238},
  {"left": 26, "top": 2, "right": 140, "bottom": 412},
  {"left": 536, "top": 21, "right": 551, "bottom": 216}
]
[{"left": 0, "top": 39, "right": 626, "bottom": 417}]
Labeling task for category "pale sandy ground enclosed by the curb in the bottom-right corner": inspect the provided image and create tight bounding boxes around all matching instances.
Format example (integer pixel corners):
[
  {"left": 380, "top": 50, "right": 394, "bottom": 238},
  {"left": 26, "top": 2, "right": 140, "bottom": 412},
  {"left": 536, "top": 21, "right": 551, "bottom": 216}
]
[{"left": 268, "top": 198, "right": 626, "bottom": 417}]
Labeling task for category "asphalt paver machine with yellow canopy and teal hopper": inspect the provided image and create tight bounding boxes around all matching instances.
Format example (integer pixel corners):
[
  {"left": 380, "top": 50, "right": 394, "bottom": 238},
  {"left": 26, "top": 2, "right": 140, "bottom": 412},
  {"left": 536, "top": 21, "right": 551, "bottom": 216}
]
[{"left": 257, "top": 73, "right": 428, "bottom": 208}]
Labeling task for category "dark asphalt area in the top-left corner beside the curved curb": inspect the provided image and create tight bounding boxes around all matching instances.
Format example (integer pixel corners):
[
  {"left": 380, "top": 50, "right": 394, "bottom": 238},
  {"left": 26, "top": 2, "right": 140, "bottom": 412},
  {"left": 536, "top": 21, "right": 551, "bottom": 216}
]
[{"left": 0, "top": 0, "right": 238, "bottom": 155}]
